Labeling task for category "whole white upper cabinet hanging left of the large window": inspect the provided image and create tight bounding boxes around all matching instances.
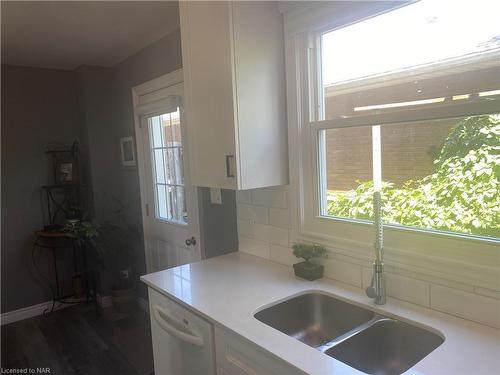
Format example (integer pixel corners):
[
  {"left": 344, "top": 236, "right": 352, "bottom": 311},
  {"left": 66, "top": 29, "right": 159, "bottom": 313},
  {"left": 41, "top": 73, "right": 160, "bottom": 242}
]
[{"left": 179, "top": 1, "right": 288, "bottom": 190}]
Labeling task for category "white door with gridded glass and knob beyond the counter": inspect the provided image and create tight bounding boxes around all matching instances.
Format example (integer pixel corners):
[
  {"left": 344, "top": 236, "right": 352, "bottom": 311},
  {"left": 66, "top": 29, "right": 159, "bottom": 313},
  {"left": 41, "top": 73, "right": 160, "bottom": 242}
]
[{"left": 137, "top": 79, "right": 201, "bottom": 272}]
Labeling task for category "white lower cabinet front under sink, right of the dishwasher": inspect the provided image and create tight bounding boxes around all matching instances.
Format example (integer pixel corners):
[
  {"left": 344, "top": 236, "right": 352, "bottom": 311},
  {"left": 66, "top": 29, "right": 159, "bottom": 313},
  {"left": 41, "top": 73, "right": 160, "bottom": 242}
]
[{"left": 215, "top": 326, "right": 303, "bottom": 375}]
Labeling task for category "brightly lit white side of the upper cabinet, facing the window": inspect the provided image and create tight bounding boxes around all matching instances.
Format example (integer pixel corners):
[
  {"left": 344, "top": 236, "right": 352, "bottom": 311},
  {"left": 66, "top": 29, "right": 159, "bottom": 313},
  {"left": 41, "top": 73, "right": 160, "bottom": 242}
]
[{"left": 232, "top": 1, "right": 288, "bottom": 190}]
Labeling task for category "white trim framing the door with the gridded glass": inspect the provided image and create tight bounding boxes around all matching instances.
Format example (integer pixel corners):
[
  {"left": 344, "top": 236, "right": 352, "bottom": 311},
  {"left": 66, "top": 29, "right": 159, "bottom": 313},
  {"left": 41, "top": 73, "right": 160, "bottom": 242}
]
[{"left": 132, "top": 69, "right": 203, "bottom": 273}]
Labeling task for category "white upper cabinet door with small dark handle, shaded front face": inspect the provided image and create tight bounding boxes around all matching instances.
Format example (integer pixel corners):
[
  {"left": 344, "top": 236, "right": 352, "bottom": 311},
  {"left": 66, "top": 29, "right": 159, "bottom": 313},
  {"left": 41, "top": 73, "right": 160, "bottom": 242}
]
[{"left": 179, "top": 1, "right": 237, "bottom": 189}]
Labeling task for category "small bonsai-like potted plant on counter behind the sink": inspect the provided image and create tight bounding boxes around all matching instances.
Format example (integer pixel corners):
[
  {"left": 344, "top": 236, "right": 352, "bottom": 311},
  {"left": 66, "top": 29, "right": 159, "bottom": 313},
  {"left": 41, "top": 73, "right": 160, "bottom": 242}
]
[{"left": 292, "top": 243, "right": 327, "bottom": 281}]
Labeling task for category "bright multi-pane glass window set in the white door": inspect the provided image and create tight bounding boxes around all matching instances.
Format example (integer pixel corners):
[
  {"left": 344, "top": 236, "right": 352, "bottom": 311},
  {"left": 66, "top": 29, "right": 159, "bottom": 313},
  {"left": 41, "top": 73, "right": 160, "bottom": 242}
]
[{"left": 148, "top": 109, "right": 188, "bottom": 224}]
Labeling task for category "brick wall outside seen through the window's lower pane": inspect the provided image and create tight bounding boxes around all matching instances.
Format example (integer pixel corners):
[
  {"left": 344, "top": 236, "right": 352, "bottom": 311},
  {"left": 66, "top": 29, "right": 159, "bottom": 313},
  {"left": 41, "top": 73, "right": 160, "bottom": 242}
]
[{"left": 325, "top": 114, "right": 457, "bottom": 190}]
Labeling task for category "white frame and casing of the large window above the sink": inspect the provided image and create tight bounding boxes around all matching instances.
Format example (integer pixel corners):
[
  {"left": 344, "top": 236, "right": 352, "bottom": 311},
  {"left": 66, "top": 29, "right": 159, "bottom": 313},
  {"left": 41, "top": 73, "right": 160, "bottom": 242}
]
[{"left": 282, "top": 3, "right": 500, "bottom": 290}]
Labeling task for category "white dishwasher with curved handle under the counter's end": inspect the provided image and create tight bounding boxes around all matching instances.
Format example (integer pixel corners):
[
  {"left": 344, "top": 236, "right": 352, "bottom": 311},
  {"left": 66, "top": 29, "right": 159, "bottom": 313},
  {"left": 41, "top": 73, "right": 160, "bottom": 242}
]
[{"left": 148, "top": 288, "right": 215, "bottom": 375}]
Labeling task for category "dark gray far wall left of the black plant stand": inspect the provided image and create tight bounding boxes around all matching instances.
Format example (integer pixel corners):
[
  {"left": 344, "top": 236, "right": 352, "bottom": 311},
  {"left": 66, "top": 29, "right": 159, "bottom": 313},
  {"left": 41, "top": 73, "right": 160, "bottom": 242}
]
[{"left": 1, "top": 65, "right": 85, "bottom": 312}]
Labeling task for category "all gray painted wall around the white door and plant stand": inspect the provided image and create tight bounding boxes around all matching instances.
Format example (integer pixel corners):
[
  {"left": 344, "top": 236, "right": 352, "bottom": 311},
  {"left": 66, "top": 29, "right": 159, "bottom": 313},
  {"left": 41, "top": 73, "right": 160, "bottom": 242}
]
[{"left": 2, "top": 30, "right": 237, "bottom": 312}]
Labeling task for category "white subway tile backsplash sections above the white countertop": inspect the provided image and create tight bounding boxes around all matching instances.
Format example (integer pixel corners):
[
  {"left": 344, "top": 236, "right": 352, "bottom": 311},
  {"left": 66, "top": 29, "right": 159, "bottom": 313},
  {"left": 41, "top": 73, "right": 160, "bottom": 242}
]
[{"left": 236, "top": 186, "right": 500, "bottom": 328}]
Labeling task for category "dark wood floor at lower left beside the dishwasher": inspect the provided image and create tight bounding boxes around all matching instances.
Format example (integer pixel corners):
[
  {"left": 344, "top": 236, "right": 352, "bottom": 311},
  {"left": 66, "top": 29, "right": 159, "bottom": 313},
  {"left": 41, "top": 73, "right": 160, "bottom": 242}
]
[{"left": 1, "top": 305, "right": 153, "bottom": 375}]
